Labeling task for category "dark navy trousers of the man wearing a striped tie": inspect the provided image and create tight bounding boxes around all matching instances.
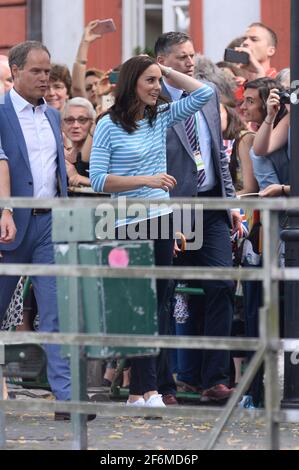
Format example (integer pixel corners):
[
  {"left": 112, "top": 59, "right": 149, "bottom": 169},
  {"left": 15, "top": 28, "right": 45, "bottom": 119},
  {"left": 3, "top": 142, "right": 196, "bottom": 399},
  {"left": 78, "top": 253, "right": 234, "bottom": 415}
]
[{"left": 175, "top": 204, "right": 234, "bottom": 389}]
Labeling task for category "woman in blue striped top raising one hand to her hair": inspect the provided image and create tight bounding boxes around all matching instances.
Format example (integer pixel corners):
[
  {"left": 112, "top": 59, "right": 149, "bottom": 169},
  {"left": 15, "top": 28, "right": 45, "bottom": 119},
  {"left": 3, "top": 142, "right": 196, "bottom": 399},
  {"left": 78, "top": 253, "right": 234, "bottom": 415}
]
[{"left": 90, "top": 55, "right": 213, "bottom": 407}]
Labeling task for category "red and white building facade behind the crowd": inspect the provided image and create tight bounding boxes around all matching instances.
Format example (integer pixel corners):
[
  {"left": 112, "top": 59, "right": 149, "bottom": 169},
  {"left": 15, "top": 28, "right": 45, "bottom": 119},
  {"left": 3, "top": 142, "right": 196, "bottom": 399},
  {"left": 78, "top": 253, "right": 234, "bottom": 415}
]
[{"left": 0, "top": 0, "right": 290, "bottom": 69}]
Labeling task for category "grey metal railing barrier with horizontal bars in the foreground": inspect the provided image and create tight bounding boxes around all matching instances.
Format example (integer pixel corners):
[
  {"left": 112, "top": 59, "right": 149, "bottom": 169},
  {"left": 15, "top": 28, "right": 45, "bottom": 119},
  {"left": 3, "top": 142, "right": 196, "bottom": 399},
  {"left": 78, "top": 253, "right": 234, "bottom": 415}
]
[{"left": 0, "top": 198, "right": 299, "bottom": 449}]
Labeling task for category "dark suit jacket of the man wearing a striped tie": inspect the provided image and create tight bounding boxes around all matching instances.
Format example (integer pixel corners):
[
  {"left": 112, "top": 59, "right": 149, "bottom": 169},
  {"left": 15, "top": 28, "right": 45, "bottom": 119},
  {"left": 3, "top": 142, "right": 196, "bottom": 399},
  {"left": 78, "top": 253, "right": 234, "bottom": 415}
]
[{"left": 162, "top": 83, "right": 236, "bottom": 219}]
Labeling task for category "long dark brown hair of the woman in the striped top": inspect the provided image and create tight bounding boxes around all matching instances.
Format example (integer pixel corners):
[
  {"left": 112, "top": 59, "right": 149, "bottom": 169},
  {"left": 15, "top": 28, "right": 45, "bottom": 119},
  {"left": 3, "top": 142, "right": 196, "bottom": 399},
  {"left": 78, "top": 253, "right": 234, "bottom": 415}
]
[{"left": 101, "top": 55, "right": 167, "bottom": 134}]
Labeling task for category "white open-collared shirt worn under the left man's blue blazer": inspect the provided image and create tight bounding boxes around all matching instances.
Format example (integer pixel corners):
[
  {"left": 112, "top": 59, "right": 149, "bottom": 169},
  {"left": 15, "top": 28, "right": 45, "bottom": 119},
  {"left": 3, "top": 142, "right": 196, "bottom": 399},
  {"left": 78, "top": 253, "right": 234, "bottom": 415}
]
[{"left": 10, "top": 88, "right": 57, "bottom": 198}]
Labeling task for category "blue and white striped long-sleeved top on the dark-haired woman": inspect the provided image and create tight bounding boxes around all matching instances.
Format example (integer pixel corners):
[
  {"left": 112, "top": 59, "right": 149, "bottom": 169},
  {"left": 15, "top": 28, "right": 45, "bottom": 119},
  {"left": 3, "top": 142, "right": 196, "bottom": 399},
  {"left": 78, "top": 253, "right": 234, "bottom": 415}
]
[{"left": 89, "top": 85, "right": 214, "bottom": 227}]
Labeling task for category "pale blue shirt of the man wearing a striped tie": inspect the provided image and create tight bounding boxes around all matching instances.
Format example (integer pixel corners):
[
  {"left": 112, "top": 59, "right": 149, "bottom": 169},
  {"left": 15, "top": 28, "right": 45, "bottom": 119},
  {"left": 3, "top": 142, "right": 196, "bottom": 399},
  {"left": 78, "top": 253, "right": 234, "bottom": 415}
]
[{"left": 164, "top": 81, "right": 217, "bottom": 192}]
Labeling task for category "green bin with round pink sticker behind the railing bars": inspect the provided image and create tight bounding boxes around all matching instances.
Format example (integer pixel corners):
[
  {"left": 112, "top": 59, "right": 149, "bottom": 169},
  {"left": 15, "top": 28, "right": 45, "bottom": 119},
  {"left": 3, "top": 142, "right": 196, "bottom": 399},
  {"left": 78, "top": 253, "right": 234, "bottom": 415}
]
[{"left": 53, "top": 210, "right": 158, "bottom": 358}]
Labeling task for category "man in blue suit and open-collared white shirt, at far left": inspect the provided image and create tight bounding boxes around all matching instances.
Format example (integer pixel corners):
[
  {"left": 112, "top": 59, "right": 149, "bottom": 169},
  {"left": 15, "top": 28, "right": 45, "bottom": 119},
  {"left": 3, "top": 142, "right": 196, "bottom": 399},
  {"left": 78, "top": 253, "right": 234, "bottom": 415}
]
[{"left": 0, "top": 41, "right": 70, "bottom": 419}]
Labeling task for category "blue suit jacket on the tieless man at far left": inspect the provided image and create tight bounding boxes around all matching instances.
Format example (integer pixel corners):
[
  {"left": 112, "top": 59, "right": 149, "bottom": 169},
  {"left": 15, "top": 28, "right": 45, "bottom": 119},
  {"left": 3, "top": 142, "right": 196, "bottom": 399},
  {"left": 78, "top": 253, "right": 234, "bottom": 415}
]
[{"left": 0, "top": 94, "right": 67, "bottom": 251}]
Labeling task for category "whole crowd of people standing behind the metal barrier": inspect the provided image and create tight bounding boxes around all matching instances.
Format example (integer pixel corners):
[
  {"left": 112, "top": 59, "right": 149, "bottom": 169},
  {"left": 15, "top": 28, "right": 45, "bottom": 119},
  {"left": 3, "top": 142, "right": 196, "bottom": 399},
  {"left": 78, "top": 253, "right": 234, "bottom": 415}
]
[{"left": 0, "top": 20, "right": 290, "bottom": 419}]
